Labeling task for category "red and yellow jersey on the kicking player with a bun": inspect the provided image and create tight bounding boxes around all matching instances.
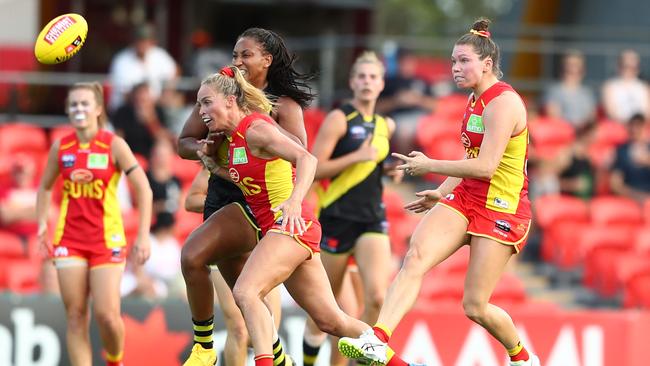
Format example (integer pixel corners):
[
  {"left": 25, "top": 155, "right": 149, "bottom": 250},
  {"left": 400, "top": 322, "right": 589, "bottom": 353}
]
[{"left": 461, "top": 82, "right": 530, "bottom": 216}]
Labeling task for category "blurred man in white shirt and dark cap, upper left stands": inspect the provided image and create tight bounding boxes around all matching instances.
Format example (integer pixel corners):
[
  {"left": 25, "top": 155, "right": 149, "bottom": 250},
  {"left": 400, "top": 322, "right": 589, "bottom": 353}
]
[{"left": 109, "top": 24, "right": 178, "bottom": 111}]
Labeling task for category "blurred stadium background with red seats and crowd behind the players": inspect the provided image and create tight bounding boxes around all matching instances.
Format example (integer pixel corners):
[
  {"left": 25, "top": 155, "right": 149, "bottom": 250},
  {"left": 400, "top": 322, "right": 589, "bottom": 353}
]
[{"left": 0, "top": 0, "right": 650, "bottom": 366}]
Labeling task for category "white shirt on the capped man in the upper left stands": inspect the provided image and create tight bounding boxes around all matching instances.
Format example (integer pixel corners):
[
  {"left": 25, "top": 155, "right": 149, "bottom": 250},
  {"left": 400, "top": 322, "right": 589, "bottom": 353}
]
[{"left": 109, "top": 46, "right": 176, "bottom": 110}]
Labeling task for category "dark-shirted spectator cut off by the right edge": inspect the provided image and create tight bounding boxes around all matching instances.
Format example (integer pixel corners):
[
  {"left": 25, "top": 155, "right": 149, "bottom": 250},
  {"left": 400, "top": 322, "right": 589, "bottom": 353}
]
[{"left": 610, "top": 114, "right": 650, "bottom": 202}]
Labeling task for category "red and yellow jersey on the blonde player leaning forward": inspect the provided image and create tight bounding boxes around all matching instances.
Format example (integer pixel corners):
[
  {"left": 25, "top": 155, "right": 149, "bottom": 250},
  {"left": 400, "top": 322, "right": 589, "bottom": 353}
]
[{"left": 228, "top": 113, "right": 316, "bottom": 234}]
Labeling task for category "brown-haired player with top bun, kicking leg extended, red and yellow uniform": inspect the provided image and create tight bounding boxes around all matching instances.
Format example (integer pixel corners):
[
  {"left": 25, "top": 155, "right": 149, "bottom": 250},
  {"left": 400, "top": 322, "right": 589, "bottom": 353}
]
[{"left": 339, "top": 19, "right": 539, "bottom": 366}]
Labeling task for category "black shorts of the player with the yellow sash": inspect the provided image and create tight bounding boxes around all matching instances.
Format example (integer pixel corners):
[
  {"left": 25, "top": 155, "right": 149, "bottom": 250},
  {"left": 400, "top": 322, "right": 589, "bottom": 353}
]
[{"left": 318, "top": 215, "right": 388, "bottom": 254}]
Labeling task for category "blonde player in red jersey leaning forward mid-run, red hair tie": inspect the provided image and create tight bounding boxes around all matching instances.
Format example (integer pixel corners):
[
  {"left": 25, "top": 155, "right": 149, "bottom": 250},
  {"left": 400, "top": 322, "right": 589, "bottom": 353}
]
[{"left": 197, "top": 67, "right": 416, "bottom": 366}]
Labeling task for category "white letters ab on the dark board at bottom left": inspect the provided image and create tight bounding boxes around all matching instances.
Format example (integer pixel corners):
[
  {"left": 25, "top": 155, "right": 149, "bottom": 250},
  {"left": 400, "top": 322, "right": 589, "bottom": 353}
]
[{"left": 0, "top": 308, "right": 61, "bottom": 366}]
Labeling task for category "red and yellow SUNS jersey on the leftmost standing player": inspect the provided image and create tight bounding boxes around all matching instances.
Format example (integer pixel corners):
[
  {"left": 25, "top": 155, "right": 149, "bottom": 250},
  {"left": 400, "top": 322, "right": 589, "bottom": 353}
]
[{"left": 54, "top": 130, "right": 126, "bottom": 248}]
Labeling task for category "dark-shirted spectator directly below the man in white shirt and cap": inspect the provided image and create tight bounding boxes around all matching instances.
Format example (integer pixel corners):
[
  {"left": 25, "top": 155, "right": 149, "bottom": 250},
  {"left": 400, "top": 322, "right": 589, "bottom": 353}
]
[{"left": 112, "top": 83, "right": 171, "bottom": 159}]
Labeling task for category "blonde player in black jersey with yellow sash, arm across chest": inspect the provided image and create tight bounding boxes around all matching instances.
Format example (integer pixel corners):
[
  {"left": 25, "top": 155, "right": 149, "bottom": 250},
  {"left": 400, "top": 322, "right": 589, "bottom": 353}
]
[{"left": 303, "top": 52, "right": 395, "bottom": 365}]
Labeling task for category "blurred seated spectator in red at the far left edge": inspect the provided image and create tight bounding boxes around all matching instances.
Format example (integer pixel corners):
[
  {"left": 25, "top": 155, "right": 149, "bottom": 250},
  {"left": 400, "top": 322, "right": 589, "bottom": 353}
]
[{"left": 0, "top": 155, "right": 38, "bottom": 242}]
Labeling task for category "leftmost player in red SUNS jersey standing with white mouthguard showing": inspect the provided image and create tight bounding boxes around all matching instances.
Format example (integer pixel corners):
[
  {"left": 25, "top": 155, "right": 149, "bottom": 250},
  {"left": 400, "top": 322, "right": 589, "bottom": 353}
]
[{"left": 36, "top": 83, "right": 152, "bottom": 366}]
